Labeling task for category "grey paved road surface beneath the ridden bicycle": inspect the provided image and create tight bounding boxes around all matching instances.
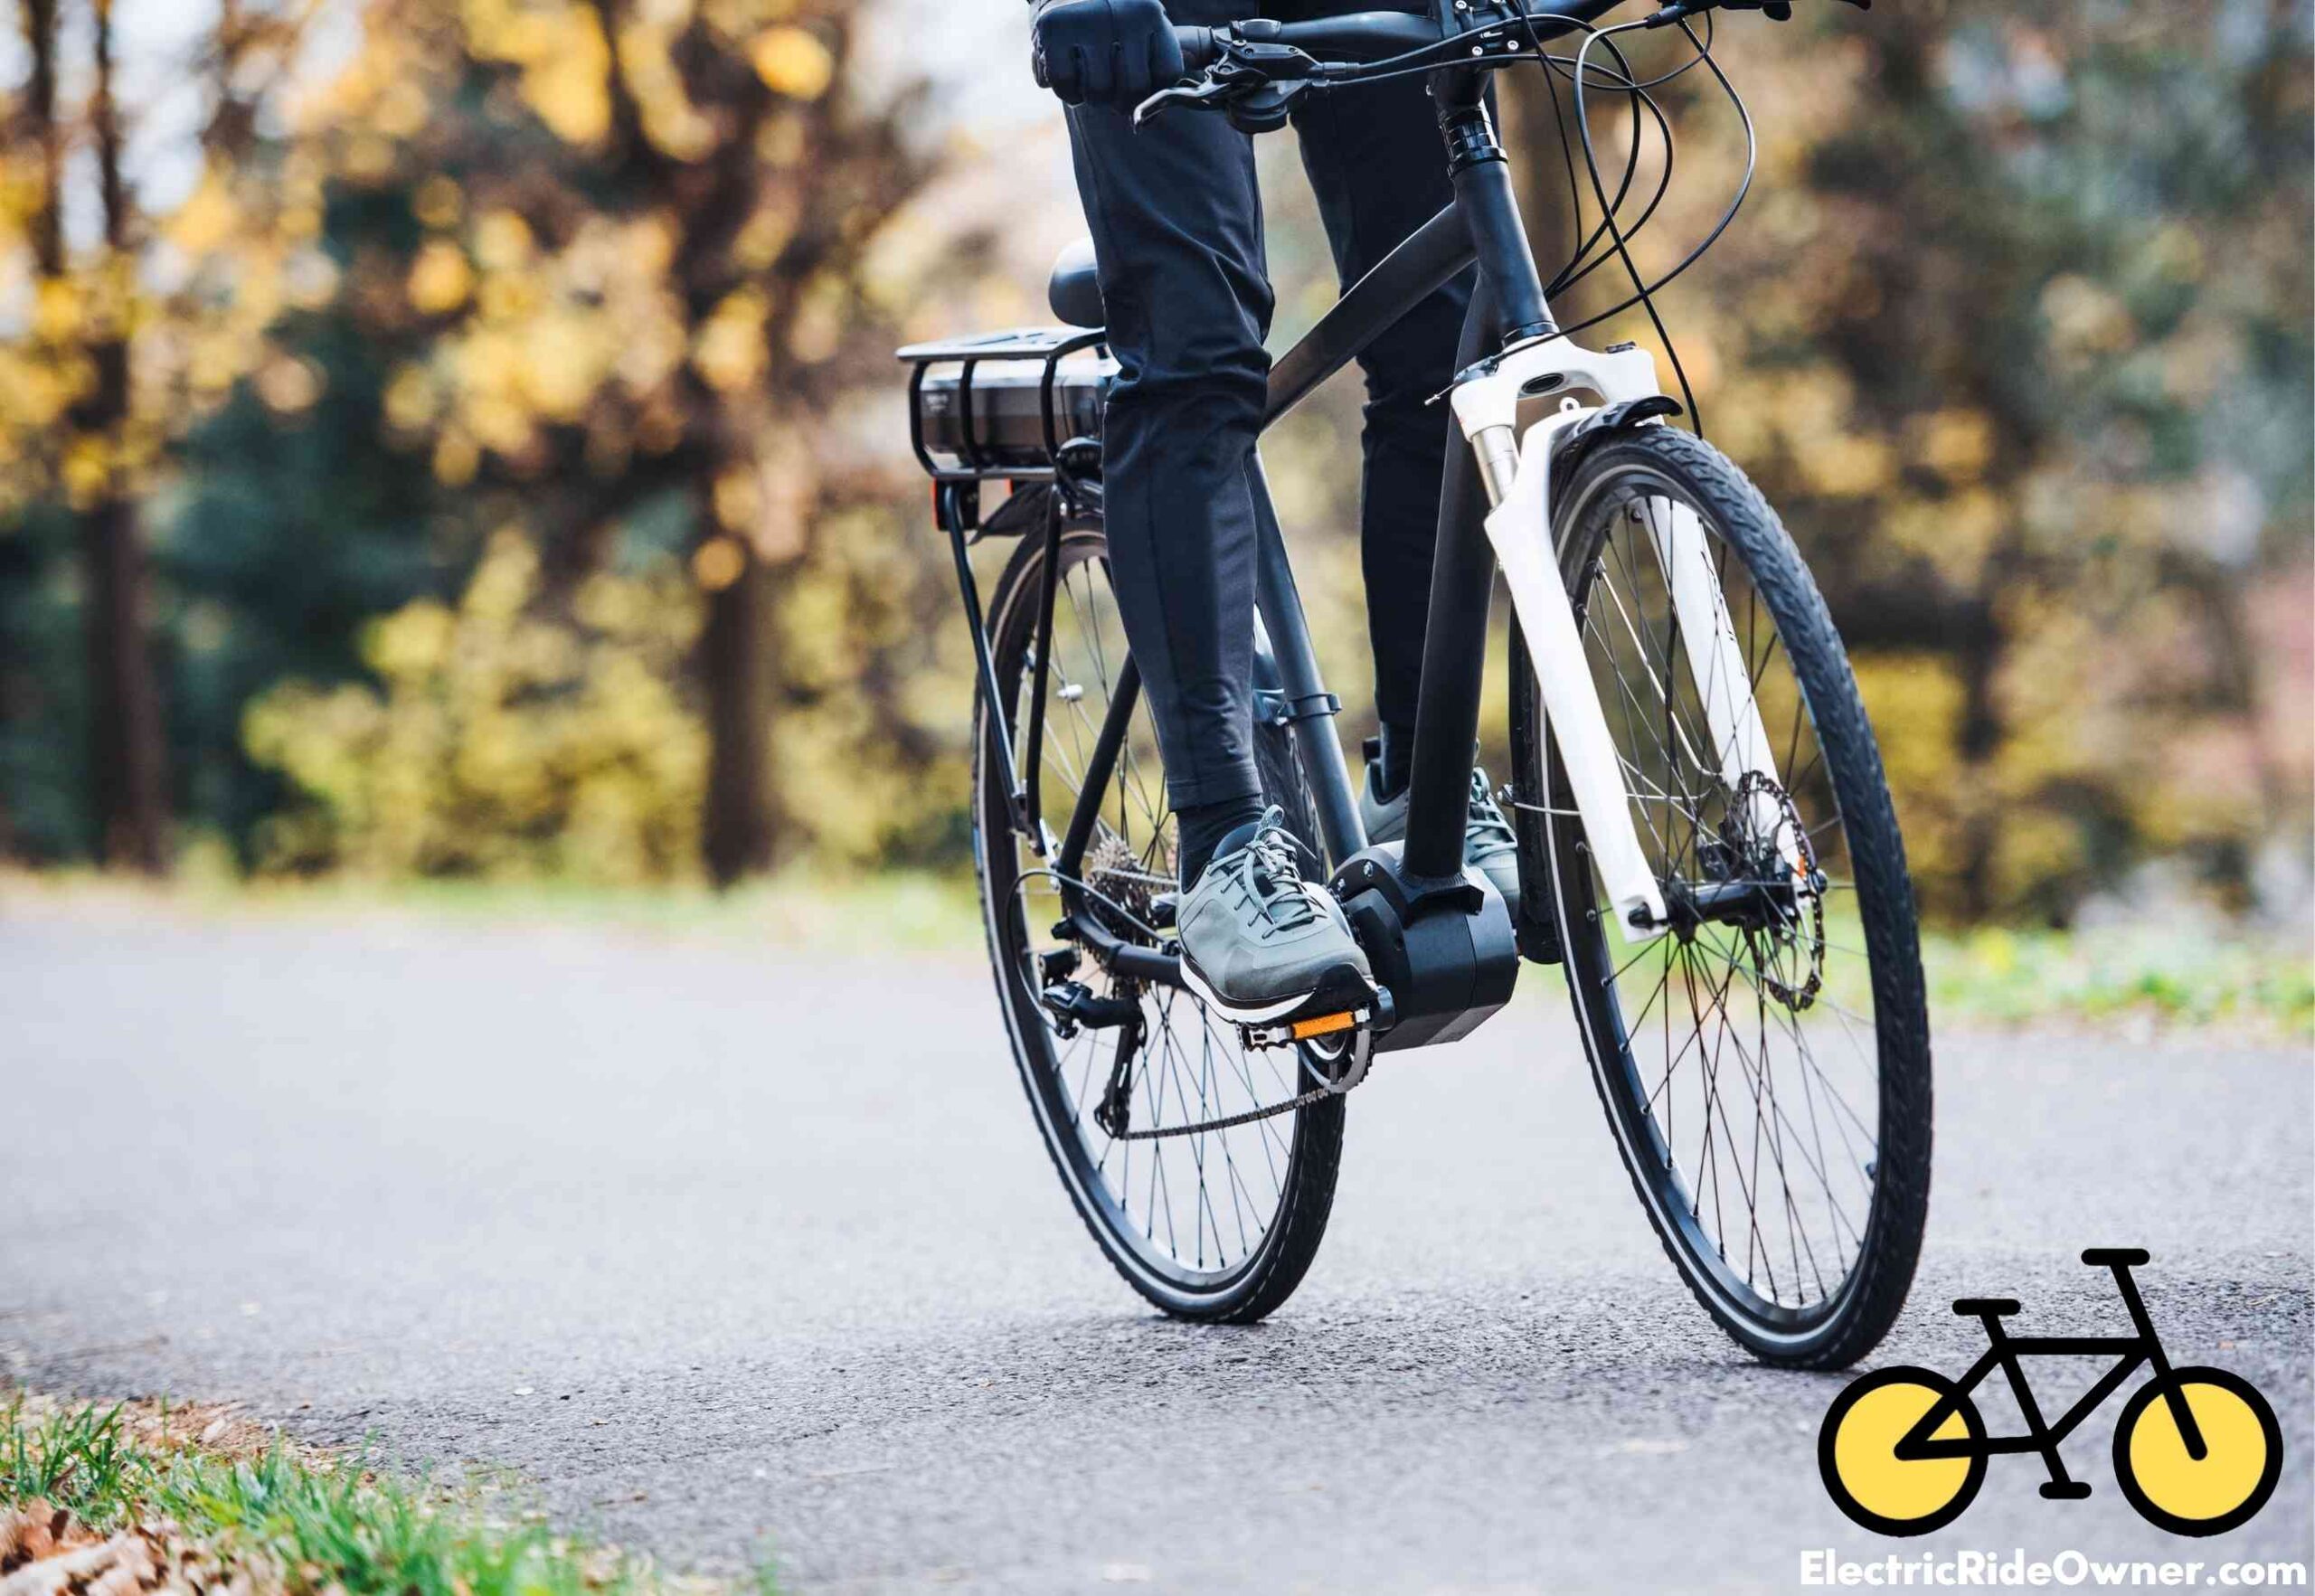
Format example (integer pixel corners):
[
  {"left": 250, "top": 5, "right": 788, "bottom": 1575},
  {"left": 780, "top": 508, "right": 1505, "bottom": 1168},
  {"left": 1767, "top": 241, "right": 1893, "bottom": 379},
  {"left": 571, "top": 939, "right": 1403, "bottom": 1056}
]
[{"left": 0, "top": 912, "right": 2315, "bottom": 1591}]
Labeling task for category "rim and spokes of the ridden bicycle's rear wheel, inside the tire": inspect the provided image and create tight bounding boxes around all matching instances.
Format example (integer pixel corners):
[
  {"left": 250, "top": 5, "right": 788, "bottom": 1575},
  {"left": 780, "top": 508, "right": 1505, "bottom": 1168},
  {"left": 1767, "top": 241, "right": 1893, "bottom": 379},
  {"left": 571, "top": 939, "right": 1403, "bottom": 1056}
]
[{"left": 984, "top": 537, "right": 1342, "bottom": 1295}]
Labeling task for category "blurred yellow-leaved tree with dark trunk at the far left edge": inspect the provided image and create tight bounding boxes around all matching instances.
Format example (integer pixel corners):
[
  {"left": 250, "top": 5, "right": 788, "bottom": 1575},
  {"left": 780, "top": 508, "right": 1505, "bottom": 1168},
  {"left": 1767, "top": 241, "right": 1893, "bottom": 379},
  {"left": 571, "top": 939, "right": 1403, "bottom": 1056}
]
[{"left": 0, "top": 0, "right": 317, "bottom": 874}]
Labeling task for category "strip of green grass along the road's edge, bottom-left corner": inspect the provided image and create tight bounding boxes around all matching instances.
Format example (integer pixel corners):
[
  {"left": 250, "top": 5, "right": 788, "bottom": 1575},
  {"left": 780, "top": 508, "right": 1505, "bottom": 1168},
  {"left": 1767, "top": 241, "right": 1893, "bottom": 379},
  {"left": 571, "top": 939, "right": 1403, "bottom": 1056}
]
[{"left": 0, "top": 1394, "right": 773, "bottom": 1596}]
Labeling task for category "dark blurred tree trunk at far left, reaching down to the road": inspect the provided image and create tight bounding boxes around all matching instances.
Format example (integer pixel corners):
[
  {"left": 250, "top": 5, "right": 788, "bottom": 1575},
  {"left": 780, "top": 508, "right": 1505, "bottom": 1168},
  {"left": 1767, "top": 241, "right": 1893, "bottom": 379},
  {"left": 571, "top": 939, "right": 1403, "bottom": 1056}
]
[{"left": 74, "top": 0, "right": 169, "bottom": 875}]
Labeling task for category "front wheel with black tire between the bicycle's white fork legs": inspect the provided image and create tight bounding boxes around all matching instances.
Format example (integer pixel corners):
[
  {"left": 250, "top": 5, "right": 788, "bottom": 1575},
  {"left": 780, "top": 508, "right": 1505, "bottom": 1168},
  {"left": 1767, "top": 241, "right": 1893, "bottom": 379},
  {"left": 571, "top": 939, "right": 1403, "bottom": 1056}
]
[{"left": 1512, "top": 426, "right": 1931, "bottom": 1369}]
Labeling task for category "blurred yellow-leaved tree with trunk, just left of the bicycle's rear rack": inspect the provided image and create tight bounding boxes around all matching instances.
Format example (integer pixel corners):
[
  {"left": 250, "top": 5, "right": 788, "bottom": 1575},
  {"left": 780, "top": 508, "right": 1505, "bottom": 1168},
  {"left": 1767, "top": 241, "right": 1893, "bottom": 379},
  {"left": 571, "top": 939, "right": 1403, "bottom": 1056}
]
[{"left": 319, "top": 0, "right": 935, "bottom": 883}]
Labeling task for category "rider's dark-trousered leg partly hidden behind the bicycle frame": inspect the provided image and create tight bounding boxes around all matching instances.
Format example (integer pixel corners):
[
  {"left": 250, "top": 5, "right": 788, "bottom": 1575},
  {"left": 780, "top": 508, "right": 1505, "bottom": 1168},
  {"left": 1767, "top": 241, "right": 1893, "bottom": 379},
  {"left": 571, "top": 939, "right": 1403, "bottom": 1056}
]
[{"left": 1294, "top": 77, "right": 1475, "bottom": 797}]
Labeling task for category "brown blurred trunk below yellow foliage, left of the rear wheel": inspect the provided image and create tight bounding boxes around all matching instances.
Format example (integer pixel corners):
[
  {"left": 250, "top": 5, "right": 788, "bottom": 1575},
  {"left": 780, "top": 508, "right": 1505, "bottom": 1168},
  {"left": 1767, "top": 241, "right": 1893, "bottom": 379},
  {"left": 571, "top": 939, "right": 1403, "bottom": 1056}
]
[{"left": 699, "top": 533, "right": 780, "bottom": 887}]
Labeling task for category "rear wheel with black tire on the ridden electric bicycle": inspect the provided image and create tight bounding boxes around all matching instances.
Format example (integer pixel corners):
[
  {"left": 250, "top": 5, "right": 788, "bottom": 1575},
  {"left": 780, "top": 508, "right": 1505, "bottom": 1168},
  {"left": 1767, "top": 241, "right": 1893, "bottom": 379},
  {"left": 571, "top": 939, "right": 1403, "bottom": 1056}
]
[{"left": 972, "top": 524, "right": 1343, "bottom": 1323}]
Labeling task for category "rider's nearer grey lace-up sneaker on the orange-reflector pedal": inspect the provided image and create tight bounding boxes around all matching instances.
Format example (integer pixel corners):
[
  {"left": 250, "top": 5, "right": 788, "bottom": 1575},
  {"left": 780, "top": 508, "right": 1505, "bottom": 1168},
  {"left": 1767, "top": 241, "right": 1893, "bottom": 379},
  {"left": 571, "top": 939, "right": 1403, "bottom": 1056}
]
[{"left": 1176, "top": 806, "right": 1373, "bottom": 1026}]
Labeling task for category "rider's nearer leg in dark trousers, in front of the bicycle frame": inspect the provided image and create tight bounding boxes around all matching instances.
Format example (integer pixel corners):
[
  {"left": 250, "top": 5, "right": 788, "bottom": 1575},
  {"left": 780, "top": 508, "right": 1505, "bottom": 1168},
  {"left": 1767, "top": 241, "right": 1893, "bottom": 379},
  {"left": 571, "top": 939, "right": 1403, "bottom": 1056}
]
[{"left": 1070, "top": 87, "right": 1271, "bottom": 885}]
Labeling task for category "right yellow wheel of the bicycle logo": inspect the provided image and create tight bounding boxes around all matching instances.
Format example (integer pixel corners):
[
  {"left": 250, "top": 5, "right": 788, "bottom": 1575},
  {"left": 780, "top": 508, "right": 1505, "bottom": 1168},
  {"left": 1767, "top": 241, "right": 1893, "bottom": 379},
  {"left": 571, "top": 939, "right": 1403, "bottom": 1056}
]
[{"left": 2113, "top": 1369, "right": 2282, "bottom": 1535}]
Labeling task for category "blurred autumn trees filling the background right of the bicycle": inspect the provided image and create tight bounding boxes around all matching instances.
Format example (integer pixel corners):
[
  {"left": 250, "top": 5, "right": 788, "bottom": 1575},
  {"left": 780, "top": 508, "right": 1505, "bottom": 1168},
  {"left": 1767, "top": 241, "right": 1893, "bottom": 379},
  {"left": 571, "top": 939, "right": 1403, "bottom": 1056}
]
[{"left": 1509, "top": 0, "right": 2315, "bottom": 920}]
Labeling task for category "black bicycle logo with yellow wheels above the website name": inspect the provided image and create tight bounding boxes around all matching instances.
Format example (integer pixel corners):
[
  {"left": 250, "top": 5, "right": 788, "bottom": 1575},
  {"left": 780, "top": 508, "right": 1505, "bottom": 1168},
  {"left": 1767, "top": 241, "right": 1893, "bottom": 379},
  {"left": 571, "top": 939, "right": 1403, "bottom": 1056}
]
[{"left": 1818, "top": 1246, "right": 2282, "bottom": 1535}]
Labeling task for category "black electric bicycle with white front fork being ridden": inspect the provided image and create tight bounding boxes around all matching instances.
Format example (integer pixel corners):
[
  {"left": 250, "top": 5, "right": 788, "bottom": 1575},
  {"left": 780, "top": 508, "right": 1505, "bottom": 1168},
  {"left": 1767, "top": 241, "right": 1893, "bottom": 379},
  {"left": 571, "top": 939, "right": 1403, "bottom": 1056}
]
[{"left": 901, "top": 0, "right": 1931, "bottom": 1366}]
